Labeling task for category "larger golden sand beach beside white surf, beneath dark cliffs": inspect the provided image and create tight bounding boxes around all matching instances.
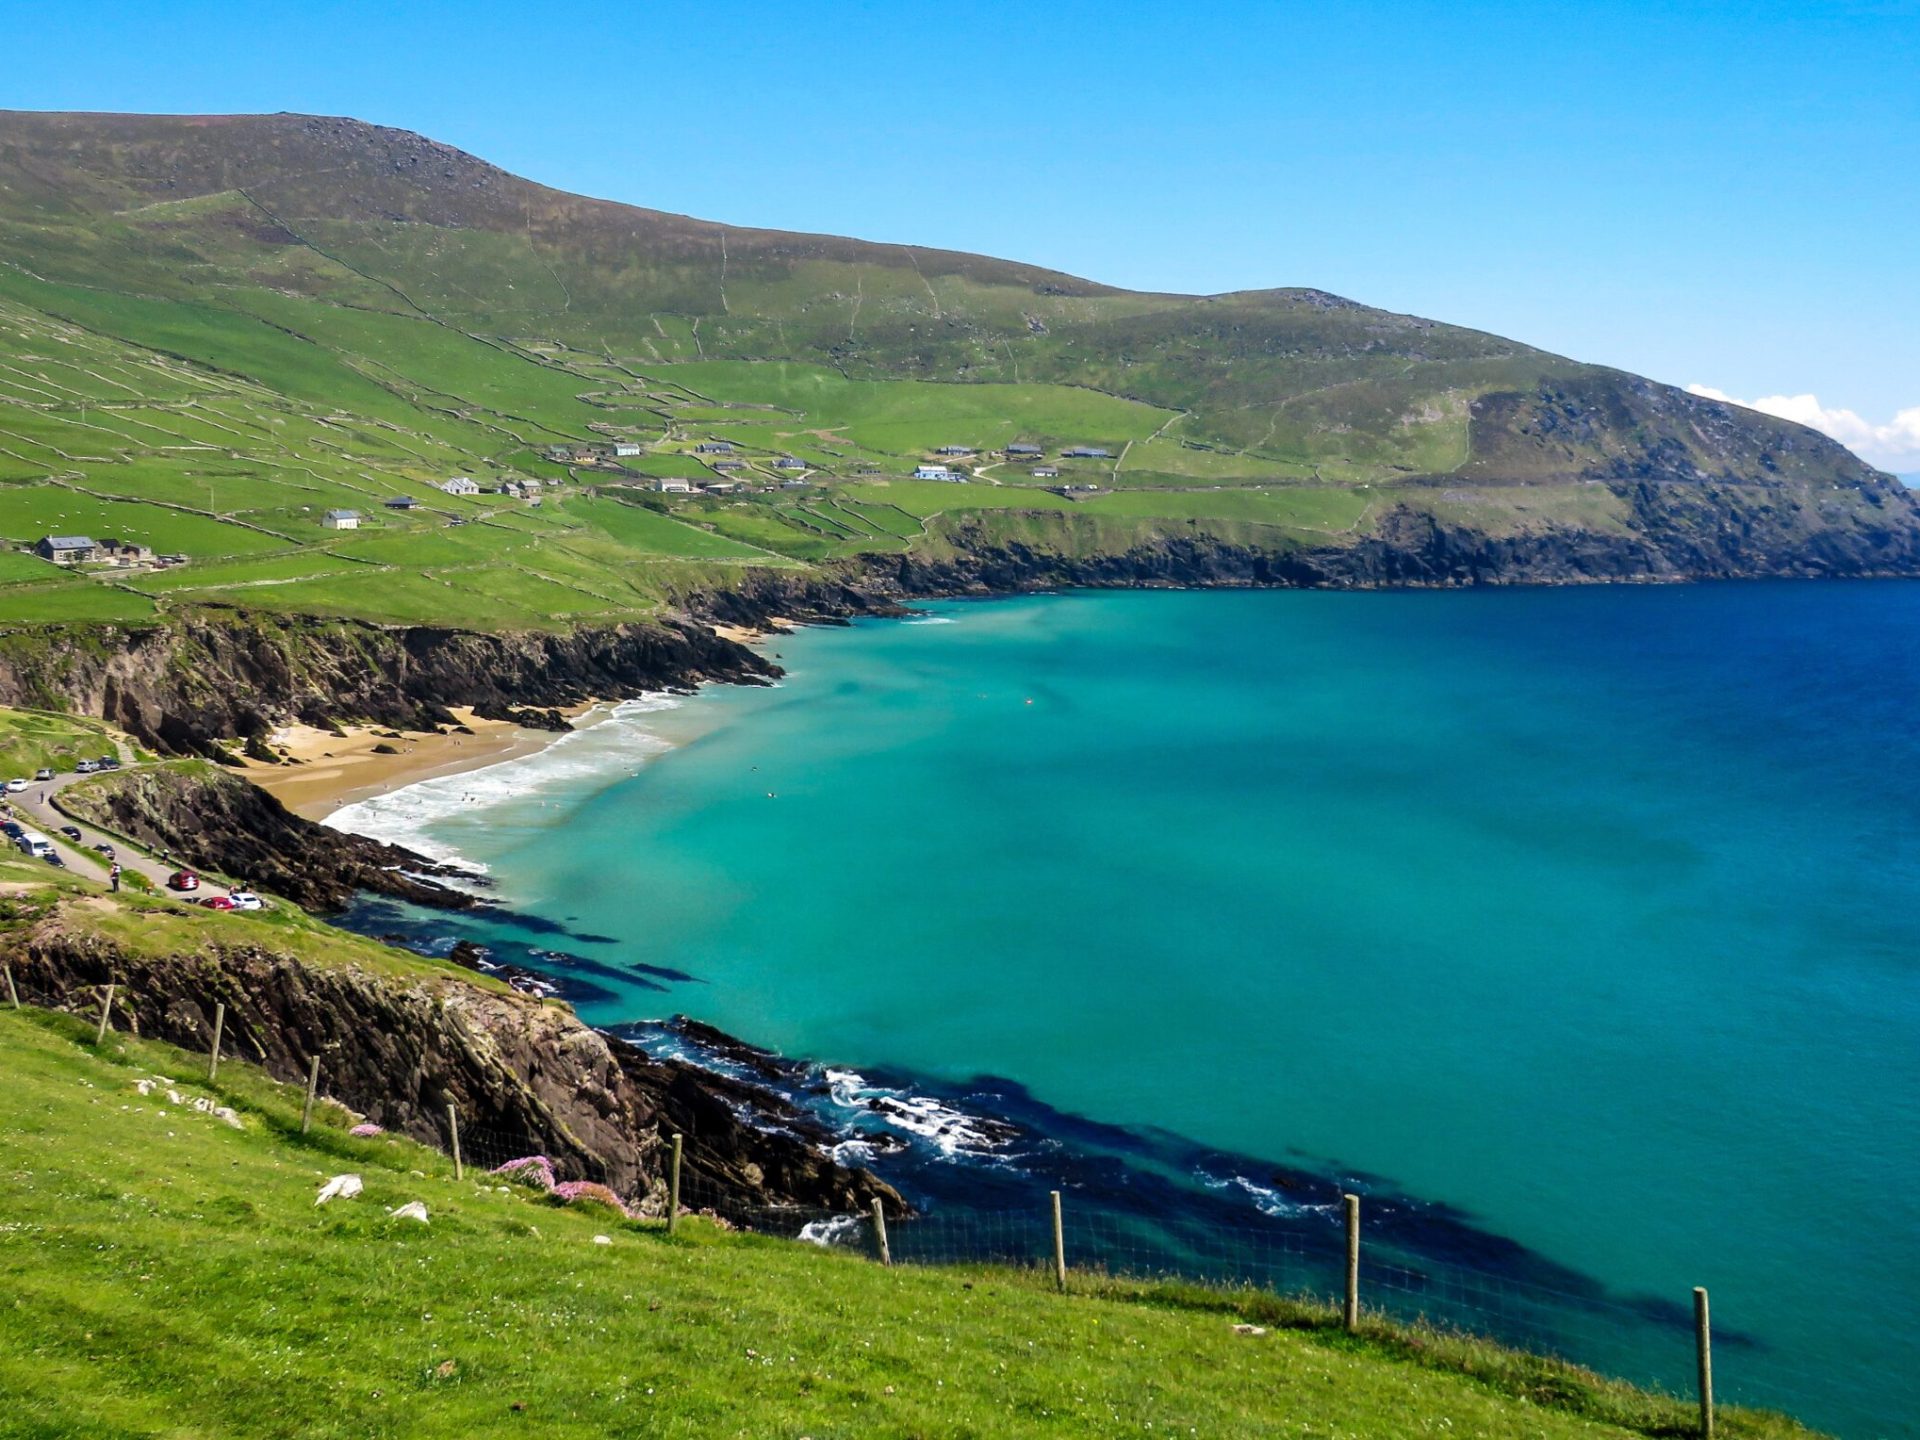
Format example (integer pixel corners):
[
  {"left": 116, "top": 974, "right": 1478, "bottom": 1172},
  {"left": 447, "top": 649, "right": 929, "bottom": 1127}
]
[{"left": 246, "top": 705, "right": 593, "bottom": 820}]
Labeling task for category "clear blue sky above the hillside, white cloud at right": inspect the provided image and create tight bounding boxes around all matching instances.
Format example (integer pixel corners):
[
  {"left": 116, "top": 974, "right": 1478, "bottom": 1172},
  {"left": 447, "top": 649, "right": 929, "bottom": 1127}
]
[{"left": 0, "top": 0, "right": 1920, "bottom": 470}]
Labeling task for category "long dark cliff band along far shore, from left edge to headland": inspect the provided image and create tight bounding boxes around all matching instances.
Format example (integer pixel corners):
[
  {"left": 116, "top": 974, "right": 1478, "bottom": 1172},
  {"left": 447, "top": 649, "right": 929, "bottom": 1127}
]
[{"left": 0, "top": 480, "right": 1920, "bottom": 771}]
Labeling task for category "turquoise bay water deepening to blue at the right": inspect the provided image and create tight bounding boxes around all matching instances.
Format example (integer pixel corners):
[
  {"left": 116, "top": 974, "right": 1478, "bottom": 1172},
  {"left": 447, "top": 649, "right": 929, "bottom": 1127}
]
[{"left": 349, "top": 584, "right": 1920, "bottom": 1434}]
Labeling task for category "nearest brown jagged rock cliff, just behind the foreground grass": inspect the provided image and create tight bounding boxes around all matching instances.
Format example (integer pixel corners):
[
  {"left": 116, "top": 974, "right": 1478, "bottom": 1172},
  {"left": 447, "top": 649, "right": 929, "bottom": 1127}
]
[{"left": 0, "top": 908, "right": 904, "bottom": 1213}]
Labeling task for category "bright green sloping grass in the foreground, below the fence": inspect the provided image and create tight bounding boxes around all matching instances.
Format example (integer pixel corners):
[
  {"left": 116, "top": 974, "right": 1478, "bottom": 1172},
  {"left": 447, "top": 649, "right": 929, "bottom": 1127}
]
[{"left": 0, "top": 1010, "right": 1805, "bottom": 1440}]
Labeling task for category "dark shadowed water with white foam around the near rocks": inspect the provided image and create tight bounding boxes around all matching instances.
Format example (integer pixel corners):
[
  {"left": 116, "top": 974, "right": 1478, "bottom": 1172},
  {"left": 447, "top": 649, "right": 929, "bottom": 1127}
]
[{"left": 336, "top": 897, "right": 1761, "bottom": 1384}]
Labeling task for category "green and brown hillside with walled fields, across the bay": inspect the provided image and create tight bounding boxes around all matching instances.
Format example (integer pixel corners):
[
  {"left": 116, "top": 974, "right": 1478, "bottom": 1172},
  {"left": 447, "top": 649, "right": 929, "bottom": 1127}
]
[{"left": 0, "top": 111, "right": 1920, "bottom": 626}]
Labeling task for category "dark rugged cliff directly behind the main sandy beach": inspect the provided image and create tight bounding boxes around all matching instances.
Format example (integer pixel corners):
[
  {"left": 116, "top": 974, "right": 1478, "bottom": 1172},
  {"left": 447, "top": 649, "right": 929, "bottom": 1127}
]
[{"left": 0, "top": 611, "right": 776, "bottom": 755}]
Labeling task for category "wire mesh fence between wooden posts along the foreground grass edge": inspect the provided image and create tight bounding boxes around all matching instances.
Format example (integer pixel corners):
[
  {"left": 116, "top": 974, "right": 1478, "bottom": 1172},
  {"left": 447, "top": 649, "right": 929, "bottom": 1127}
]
[{"left": 45, "top": 1010, "right": 1889, "bottom": 1436}]
